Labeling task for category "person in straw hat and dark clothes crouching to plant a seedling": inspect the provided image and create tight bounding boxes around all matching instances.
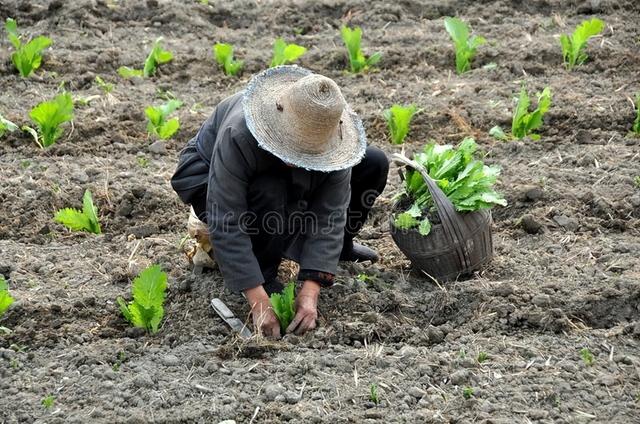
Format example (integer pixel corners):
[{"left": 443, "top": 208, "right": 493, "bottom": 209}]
[{"left": 171, "top": 66, "right": 389, "bottom": 337}]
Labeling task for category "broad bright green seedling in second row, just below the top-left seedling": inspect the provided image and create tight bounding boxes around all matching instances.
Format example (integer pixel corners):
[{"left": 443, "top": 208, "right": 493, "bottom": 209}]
[{"left": 29, "top": 93, "right": 73, "bottom": 148}]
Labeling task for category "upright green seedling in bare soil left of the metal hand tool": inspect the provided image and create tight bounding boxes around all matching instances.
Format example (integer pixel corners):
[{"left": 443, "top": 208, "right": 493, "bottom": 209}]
[{"left": 117, "top": 265, "right": 167, "bottom": 334}]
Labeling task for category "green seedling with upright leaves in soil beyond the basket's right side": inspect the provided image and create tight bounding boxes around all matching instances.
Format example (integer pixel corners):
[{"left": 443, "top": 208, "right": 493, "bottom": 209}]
[{"left": 489, "top": 86, "right": 551, "bottom": 140}]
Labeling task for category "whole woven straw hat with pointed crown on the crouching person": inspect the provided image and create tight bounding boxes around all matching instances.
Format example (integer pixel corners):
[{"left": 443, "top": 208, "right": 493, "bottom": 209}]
[{"left": 243, "top": 66, "right": 367, "bottom": 172}]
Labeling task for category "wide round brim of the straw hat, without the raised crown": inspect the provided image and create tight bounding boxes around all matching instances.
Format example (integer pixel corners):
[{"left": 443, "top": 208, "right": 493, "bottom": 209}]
[{"left": 243, "top": 66, "right": 367, "bottom": 172}]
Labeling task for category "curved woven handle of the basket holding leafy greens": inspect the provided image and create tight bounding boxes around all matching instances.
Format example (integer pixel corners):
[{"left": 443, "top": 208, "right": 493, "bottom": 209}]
[{"left": 392, "top": 153, "right": 472, "bottom": 268}]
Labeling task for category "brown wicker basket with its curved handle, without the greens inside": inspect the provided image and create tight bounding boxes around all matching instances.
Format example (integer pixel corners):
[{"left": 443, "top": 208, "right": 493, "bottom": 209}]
[{"left": 391, "top": 154, "right": 493, "bottom": 281}]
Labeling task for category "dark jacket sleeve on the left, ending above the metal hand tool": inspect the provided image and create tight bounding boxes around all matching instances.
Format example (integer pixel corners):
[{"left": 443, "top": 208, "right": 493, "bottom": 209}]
[{"left": 207, "top": 127, "right": 264, "bottom": 292}]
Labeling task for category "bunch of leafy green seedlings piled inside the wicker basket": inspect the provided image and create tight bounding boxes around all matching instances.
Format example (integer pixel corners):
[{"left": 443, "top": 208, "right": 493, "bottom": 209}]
[{"left": 394, "top": 138, "right": 507, "bottom": 235}]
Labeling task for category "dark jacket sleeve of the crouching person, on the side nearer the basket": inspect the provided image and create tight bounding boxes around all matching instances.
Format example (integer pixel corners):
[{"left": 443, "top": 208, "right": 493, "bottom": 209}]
[{"left": 300, "top": 169, "right": 351, "bottom": 274}]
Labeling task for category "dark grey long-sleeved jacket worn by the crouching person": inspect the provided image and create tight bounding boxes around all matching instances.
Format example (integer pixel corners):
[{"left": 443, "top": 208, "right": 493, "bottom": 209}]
[{"left": 171, "top": 93, "right": 351, "bottom": 291}]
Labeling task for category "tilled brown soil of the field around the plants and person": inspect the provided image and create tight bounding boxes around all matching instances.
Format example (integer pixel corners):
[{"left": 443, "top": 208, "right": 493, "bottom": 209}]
[{"left": 0, "top": 0, "right": 640, "bottom": 423}]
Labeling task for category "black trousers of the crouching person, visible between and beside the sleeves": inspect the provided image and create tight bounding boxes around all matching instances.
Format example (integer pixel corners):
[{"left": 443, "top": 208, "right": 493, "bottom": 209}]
[{"left": 191, "top": 146, "right": 389, "bottom": 280}]
